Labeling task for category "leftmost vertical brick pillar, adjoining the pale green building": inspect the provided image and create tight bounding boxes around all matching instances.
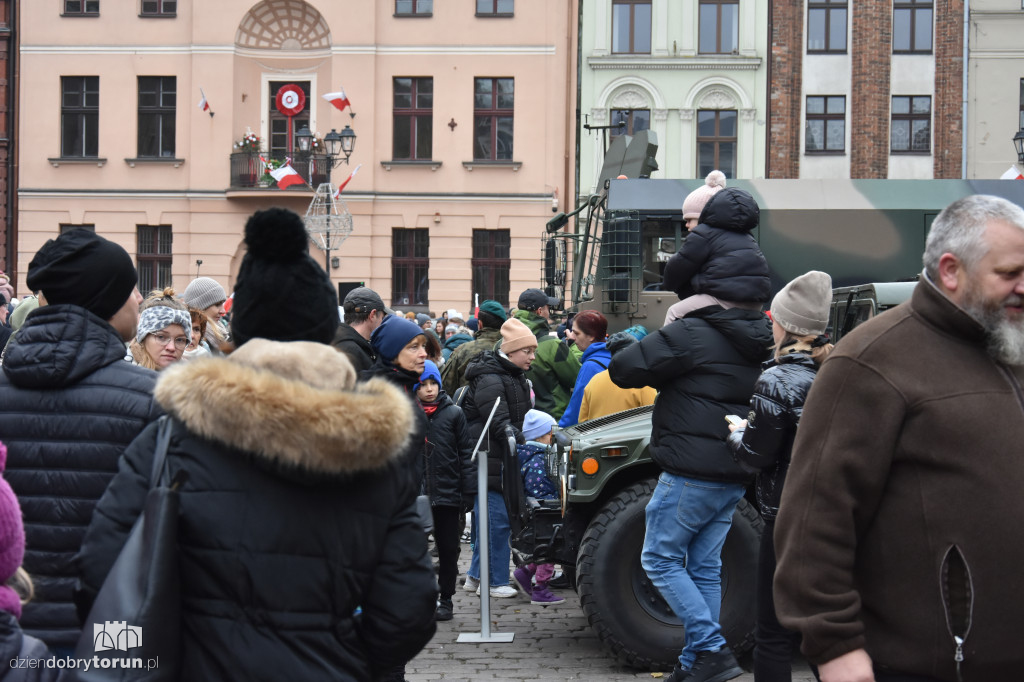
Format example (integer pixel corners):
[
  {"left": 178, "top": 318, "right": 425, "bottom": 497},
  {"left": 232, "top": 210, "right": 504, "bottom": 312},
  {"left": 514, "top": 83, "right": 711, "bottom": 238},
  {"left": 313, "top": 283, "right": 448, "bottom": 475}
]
[{"left": 767, "top": 2, "right": 804, "bottom": 178}]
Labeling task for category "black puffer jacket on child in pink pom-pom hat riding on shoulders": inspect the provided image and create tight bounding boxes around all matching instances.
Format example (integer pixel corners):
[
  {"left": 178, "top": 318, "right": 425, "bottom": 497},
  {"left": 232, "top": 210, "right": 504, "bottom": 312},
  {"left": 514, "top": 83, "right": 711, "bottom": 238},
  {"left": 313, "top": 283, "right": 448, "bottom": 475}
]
[{"left": 662, "top": 187, "right": 771, "bottom": 302}]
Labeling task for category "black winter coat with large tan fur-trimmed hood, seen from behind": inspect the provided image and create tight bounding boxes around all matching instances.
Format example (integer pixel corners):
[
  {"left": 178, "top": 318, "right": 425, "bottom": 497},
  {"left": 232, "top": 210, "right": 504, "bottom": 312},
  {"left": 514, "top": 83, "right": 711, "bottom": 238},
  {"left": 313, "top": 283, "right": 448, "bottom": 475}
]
[{"left": 74, "top": 339, "right": 437, "bottom": 682}]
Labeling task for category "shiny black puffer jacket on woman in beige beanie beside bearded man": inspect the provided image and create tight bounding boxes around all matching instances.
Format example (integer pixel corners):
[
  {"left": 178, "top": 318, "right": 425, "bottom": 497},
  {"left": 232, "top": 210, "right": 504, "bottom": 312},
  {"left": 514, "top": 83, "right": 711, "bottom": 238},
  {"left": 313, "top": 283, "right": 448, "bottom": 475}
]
[{"left": 729, "top": 352, "right": 818, "bottom": 520}]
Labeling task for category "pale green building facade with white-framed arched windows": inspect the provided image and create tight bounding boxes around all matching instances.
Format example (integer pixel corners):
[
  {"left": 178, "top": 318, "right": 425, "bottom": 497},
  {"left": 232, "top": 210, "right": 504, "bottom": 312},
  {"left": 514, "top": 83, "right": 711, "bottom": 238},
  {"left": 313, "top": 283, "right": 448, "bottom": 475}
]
[{"left": 580, "top": 0, "right": 768, "bottom": 195}]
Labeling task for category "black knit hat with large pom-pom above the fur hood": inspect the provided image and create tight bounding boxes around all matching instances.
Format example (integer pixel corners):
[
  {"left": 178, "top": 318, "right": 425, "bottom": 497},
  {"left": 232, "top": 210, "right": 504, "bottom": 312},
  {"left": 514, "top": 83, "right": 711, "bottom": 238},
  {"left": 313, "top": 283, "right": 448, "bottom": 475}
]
[{"left": 231, "top": 208, "right": 339, "bottom": 346}]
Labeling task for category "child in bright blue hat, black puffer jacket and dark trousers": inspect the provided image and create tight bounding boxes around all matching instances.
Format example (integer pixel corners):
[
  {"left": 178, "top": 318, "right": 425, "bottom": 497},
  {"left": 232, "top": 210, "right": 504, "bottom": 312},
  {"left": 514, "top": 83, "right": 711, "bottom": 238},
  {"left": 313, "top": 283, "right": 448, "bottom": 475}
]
[{"left": 416, "top": 360, "right": 476, "bottom": 621}]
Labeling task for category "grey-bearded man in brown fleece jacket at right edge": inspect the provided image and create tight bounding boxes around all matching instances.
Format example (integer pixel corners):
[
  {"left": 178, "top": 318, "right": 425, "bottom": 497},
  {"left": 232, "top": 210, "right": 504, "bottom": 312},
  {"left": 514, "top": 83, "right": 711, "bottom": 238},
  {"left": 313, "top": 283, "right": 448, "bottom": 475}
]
[{"left": 775, "top": 196, "right": 1024, "bottom": 682}]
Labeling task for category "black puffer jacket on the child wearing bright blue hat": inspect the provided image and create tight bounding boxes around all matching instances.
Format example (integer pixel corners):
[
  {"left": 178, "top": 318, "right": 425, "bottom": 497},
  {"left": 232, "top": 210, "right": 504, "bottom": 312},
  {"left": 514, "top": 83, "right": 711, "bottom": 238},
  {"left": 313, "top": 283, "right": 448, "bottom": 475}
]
[{"left": 424, "top": 391, "right": 476, "bottom": 510}]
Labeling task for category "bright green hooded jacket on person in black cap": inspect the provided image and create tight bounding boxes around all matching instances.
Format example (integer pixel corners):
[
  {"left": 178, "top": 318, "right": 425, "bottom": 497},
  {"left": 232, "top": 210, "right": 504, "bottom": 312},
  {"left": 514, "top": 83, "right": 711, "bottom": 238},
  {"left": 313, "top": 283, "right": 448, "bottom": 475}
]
[{"left": 515, "top": 310, "right": 583, "bottom": 420}]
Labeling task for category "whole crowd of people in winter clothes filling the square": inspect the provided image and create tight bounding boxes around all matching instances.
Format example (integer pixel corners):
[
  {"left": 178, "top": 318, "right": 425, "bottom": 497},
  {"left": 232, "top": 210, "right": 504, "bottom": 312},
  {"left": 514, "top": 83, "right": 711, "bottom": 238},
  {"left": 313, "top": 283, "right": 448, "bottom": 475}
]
[{"left": 0, "top": 180, "right": 1024, "bottom": 682}]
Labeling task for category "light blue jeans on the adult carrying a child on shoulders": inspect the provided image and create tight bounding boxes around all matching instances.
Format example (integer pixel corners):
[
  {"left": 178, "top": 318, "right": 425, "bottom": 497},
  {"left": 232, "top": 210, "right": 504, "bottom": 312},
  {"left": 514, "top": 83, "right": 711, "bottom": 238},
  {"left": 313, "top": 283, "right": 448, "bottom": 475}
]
[{"left": 640, "top": 472, "right": 744, "bottom": 670}]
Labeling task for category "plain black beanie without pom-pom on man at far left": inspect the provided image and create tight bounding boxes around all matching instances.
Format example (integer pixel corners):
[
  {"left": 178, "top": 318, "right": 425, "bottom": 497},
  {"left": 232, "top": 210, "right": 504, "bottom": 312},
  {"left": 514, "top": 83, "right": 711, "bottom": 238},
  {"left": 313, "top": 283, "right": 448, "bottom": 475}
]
[{"left": 26, "top": 229, "right": 138, "bottom": 319}]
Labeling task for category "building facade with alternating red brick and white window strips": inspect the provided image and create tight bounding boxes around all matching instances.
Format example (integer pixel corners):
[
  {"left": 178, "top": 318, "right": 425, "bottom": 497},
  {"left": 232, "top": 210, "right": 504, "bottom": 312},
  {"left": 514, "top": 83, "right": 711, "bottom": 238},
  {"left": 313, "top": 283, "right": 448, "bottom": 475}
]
[{"left": 768, "top": 0, "right": 965, "bottom": 179}]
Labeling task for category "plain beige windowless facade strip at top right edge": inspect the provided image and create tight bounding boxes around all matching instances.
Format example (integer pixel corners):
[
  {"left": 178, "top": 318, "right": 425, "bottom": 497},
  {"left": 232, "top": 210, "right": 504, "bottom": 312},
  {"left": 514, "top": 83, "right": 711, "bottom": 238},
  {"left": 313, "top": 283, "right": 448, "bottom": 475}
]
[{"left": 967, "top": 0, "right": 1024, "bottom": 178}]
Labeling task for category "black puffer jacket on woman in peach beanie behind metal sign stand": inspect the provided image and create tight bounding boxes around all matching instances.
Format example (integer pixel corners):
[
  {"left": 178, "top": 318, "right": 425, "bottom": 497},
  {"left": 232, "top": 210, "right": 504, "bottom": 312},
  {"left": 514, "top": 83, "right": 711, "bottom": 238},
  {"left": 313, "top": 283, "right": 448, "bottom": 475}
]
[{"left": 462, "top": 350, "right": 531, "bottom": 492}]
